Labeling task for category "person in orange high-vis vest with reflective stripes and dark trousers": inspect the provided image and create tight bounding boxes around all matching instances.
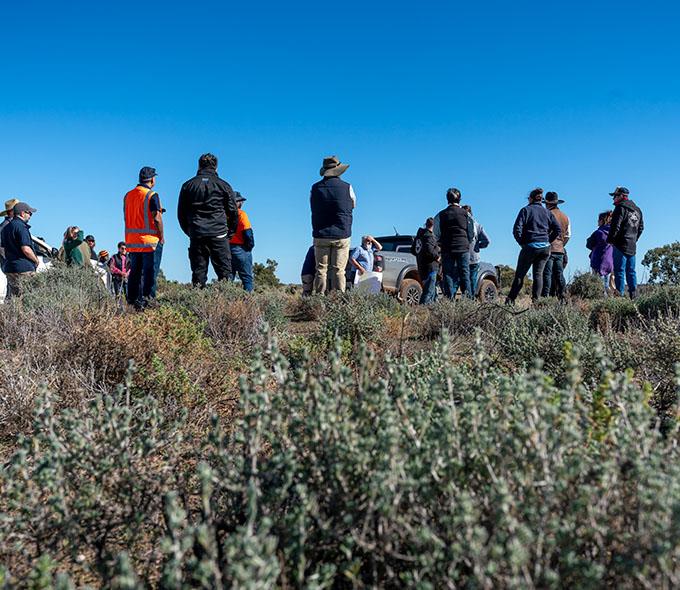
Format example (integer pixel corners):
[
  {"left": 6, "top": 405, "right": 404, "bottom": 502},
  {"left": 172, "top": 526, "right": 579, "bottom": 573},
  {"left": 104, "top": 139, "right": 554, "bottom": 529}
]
[{"left": 123, "top": 166, "right": 165, "bottom": 311}]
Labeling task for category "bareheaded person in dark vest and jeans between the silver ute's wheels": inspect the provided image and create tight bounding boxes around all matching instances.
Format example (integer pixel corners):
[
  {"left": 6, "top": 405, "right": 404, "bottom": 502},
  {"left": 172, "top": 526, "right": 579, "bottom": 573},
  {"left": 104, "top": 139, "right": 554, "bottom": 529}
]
[{"left": 433, "top": 188, "right": 475, "bottom": 299}]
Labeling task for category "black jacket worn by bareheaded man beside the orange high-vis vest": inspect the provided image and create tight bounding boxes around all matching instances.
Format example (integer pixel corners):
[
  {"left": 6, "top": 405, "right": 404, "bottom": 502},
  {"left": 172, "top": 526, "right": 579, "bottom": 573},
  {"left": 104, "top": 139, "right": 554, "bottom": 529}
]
[{"left": 177, "top": 168, "right": 238, "bottom": 238}]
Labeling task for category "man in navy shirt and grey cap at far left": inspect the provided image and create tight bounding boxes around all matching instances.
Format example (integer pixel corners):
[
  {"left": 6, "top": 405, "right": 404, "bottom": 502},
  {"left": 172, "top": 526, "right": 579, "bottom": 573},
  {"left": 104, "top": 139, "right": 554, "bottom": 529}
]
[{"left": 0, "top": 203, "right": 39, "bottom": 297}]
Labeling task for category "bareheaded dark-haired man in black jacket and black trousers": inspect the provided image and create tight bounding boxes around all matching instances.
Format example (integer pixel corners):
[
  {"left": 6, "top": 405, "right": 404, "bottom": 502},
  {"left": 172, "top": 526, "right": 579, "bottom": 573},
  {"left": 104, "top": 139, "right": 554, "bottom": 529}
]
[{"left": 177, "top": 154, "right": 238, "bottom": 287}]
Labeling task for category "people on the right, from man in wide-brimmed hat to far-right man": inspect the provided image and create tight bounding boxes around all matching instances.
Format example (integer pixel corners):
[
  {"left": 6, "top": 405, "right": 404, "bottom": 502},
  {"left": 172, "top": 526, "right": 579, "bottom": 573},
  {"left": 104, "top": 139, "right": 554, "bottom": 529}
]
[{"left": 301, "top": 156, "right": 644, "bottom": 304}]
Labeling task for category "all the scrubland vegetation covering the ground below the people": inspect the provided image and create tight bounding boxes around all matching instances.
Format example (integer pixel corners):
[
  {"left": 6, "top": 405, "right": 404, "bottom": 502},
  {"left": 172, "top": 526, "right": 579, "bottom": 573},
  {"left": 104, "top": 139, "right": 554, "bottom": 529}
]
[{"left": 0, "top": 269, "right": 680, "bottom": 590}]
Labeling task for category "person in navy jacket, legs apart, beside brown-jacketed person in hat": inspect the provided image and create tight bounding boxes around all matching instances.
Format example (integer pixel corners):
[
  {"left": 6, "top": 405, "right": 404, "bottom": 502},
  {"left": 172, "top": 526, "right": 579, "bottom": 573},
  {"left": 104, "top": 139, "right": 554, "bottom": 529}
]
[{"left": 505, "top": 188, "right": 562, "bottom": 303}]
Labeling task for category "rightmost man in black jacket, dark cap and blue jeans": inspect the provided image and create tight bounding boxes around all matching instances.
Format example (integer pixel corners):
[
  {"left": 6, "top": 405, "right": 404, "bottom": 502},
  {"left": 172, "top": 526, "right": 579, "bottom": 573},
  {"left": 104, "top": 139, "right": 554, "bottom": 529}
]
[{"left": 607, "top": 186, "right": 645, "bottom": 299}]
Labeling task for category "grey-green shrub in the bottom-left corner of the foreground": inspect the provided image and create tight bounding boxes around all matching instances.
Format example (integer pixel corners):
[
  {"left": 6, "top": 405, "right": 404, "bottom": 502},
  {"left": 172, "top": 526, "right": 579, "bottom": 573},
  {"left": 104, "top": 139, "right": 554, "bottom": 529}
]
[{"left": 0, "top": 366, "right": 183, "bottom": 579}]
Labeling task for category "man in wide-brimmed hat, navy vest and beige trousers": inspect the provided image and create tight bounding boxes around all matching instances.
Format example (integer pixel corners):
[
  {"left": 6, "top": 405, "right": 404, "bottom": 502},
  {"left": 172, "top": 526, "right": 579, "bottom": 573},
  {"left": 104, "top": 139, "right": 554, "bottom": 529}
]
[{"left": 309, "top": 156, "right": 356, "bottom": 293}]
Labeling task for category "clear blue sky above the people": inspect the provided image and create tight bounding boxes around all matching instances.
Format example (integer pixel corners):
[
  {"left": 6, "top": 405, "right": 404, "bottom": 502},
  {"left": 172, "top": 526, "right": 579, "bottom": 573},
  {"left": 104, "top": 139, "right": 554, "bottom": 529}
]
[{"left": 0, "top": 1, "right": 680, "bottom": 282}]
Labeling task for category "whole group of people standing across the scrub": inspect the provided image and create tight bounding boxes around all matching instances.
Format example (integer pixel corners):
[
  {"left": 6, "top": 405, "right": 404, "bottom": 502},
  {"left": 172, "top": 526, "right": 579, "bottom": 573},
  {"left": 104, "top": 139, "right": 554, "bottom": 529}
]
[{"left": 0, "top": 154, "right": 644, "bottom": 310}]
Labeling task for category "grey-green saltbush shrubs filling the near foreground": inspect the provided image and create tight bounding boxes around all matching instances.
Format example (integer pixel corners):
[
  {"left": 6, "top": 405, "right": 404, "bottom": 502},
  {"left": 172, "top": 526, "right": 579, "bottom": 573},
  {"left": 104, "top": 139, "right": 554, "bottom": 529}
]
[{"left": 0, "top": 340, "right": 680, "bottom": 590}]
